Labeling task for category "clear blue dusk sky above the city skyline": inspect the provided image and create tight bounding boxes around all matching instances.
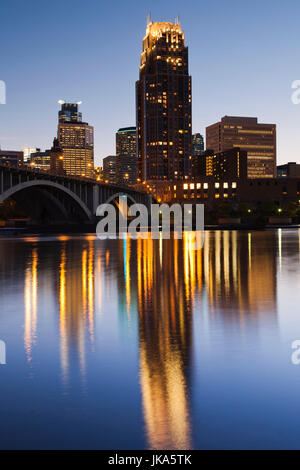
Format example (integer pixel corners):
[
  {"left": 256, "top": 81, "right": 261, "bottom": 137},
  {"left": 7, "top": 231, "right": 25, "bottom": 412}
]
[{"left": 0, "top": 0, "right": 300, "bottom": 164}]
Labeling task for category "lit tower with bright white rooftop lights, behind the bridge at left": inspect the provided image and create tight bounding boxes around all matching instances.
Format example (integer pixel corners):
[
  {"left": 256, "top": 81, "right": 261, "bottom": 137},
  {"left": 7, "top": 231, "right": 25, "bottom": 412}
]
[{"left": 57, "top": 101, "right": 94, "bottom": 178}]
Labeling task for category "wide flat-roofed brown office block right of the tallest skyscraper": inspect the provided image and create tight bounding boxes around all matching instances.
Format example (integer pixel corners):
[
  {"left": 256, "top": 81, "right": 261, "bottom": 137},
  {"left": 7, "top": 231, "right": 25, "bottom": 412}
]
[{"left": 206, "top": 116, "right": 276, "bottom": 178}]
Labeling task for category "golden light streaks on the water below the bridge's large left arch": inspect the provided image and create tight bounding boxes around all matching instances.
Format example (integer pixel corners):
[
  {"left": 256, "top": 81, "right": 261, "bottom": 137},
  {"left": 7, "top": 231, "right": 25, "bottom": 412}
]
[{"left": 24, "top": 237, "right": 96, "bottom": 382}]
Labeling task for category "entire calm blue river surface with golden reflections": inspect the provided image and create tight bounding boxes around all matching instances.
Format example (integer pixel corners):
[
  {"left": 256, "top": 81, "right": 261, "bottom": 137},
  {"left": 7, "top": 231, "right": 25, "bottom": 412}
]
[{"left": 0, "top": 230, "right": 300, "bottom": 449}]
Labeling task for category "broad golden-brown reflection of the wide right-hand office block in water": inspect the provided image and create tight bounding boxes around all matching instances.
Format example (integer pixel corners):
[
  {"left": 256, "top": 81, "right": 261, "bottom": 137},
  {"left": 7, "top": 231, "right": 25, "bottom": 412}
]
[{"left": 203, "top": 231, "right": 276, "bottom": 320}]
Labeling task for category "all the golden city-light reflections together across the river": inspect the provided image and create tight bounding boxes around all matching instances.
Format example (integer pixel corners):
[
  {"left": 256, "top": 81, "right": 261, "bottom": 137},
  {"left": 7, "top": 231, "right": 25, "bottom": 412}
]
[{"left": 20, "top": 231, "right": 282, "bottom": 449}]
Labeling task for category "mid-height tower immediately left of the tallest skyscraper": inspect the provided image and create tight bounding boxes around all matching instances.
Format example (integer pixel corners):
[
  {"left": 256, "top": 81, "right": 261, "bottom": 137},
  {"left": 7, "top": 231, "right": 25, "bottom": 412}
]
[{"left": 116, "top": 127, "right": 137, "bottom": 185}]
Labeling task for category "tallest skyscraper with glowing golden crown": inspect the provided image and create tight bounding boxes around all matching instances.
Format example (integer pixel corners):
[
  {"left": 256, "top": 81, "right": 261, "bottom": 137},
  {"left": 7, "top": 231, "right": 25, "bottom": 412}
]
[{"left": 136, "top": 19, "right": 192, "bottom": 181}]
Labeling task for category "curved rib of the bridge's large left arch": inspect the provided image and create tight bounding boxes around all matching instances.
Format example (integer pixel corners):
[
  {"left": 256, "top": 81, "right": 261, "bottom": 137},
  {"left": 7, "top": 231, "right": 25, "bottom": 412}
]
[{"left": 0, "top": 179, "right": 93, "bottom": 221}]
